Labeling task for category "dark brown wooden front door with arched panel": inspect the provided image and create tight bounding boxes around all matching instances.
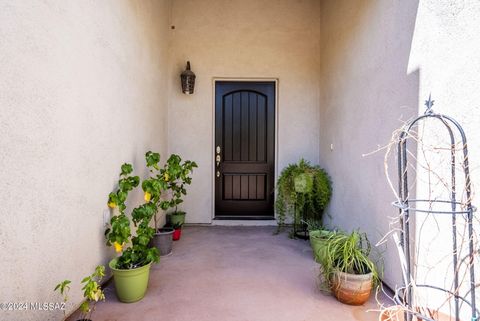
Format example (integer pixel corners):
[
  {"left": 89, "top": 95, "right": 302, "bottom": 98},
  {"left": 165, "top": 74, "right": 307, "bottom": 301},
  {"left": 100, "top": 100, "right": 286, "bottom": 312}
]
[{"left": 214, "top": 81, "right": 275, "bottom": 219}]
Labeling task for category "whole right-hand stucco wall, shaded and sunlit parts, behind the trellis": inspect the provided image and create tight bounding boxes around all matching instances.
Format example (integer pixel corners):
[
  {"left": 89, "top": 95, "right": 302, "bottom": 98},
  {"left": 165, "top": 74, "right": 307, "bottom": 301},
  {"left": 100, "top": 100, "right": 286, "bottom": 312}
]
[{"left": 320, "top": 0, "right": 480, "bottom": 301}]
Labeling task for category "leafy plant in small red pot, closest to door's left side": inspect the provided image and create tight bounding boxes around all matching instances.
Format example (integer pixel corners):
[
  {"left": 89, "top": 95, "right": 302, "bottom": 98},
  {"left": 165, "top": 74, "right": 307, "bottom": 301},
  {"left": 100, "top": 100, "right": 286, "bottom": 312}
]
[{"left": 160, "top": 154, "right": 198, "bottom": 226}]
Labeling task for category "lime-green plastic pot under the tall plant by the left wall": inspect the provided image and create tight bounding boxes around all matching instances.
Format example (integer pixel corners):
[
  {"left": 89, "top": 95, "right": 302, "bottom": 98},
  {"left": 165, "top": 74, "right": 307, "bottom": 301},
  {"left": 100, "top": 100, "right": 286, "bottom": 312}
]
[{"left": 108, "top": 258, "right": 152, "bottom": 303}]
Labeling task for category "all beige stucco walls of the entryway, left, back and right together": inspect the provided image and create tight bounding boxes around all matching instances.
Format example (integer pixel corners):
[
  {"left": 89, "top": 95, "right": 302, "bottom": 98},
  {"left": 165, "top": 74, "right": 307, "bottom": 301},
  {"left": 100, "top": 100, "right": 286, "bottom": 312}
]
[{"left": 0, "top": 0, "right": 480, "bottom": 320}]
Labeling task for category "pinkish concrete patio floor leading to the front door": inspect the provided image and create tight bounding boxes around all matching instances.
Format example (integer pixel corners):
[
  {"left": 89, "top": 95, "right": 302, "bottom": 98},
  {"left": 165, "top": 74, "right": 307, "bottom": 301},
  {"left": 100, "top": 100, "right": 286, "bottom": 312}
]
[{"left": 77, "top": 226, "right": 388, "bottom": 321}]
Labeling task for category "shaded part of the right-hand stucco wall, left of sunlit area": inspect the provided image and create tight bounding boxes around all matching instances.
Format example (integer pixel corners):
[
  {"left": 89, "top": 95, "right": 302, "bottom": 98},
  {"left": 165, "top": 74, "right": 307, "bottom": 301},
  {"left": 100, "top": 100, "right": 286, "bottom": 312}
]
[{"left": 320, "top": 0, "right": 419, "bottom": 287}]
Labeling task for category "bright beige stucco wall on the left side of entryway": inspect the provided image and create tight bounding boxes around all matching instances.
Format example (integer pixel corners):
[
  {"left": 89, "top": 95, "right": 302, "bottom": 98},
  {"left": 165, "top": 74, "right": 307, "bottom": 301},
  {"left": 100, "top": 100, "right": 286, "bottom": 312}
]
[{"left": 0, "top": 0, "right": 170, "bottom": 321}]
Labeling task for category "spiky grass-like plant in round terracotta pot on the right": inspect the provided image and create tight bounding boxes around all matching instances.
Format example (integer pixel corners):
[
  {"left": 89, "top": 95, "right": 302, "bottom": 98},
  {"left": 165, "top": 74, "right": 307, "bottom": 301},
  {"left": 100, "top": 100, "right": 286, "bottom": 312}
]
[{"left": 322, "top": 231, "right": 380, "bottom": 305}]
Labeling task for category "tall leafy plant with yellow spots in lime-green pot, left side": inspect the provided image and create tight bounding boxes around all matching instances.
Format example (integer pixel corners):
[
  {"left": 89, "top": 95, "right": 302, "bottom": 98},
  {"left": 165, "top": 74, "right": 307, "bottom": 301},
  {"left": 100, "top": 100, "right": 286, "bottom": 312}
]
[{"left": 105, "top": 164, "right": 159, "bottom": 302}]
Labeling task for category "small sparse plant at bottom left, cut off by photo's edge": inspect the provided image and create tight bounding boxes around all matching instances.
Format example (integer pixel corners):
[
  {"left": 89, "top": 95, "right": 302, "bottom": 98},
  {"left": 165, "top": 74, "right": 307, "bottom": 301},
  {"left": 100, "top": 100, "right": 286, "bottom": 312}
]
[{"left": 54, "top": 265, "right": 105, "bottom": 321}]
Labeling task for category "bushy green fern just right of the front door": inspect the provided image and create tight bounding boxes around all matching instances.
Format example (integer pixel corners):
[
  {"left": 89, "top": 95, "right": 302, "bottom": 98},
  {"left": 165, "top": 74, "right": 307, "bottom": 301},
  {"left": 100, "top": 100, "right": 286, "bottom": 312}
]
[{"left": 275, "top": 158, "right": 332, "bottom": 230}]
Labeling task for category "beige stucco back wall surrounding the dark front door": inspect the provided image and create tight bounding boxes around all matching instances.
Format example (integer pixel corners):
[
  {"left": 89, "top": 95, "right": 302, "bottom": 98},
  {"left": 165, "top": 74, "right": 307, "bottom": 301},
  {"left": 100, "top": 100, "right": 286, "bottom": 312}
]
[{"left": 168, "top": 0, "right": 320, "bottom": 223}]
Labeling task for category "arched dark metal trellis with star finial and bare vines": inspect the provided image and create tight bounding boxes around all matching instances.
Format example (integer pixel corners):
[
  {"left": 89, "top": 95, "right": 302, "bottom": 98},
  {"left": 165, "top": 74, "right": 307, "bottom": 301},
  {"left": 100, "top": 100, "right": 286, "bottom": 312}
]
[{"left": 393, "top": 96, "right": 480, "bottom": 321}]
